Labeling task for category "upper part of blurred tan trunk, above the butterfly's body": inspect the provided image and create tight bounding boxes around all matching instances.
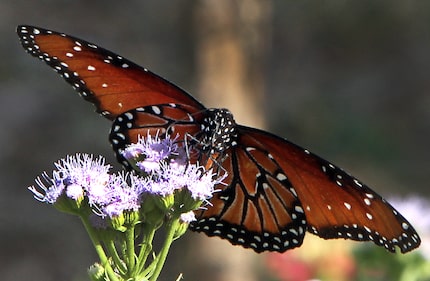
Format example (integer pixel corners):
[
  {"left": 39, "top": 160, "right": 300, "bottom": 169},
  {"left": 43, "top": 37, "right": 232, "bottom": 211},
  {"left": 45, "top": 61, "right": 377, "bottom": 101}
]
[{"left": 194, "top": 0, "right": 271, "bottom": 127}]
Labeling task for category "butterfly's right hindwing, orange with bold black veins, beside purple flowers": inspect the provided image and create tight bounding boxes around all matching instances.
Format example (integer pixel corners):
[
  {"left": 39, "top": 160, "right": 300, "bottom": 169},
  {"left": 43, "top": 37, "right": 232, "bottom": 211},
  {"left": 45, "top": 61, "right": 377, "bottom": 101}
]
[{"left": 190, "top": 131, "right": 306, "bottom": 252}]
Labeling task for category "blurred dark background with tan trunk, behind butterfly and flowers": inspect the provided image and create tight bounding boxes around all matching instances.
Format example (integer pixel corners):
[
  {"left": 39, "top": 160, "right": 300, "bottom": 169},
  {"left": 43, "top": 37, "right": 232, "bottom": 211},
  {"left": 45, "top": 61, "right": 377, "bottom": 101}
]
[{"left": 0, "top": 0, "right": 430, "bottom": 281}]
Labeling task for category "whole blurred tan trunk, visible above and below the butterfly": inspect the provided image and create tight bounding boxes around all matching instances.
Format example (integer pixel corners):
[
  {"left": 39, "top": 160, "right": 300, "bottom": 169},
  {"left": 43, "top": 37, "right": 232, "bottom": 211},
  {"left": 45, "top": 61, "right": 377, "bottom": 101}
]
[{"left": 185, "top": 0, "right": 271, "bottom": 281}]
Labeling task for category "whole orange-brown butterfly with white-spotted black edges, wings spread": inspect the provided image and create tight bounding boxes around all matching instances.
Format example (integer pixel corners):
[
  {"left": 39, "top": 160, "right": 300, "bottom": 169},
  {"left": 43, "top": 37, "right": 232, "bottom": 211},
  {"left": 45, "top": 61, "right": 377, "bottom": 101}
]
[{"left": 17, "top": 26, "right": 420, "bottom": 253}]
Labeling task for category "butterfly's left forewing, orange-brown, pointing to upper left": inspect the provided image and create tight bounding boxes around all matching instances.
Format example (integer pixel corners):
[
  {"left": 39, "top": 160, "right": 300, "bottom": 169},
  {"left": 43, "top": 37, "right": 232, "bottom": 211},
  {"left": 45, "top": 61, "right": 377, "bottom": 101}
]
[{"left": 18, "top": 26, "right": 204, "bottom": 120}]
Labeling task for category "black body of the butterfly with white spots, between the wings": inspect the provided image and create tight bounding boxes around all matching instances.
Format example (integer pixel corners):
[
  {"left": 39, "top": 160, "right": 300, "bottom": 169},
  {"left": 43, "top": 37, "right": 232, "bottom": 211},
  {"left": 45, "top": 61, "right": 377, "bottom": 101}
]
[{"left": 200, "top": 108, "right": 237, "bottom": 153}]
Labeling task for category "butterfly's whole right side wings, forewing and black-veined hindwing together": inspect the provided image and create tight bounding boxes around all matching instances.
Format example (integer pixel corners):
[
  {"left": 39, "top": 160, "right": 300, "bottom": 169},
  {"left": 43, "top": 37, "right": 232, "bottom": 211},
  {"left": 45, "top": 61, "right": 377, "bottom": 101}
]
[{"left": 193, "top": 126, "right": 420, "bottom": 252}]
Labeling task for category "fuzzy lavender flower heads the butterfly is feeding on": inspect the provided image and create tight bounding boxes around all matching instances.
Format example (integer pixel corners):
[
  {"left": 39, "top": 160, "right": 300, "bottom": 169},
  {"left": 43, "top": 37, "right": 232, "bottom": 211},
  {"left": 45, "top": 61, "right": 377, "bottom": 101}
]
[{"left": 29, "top": 135, "right": 219, "bottom": 221}]
